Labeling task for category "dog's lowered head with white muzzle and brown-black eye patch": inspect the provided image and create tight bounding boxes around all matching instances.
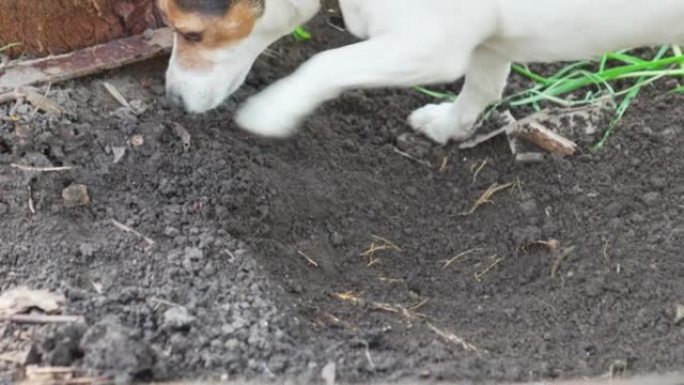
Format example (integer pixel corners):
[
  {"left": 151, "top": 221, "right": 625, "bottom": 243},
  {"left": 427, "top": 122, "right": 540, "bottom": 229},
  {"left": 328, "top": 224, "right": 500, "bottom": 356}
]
[{"left": 158, "top": 0, "right": 318, "bottom": 112}]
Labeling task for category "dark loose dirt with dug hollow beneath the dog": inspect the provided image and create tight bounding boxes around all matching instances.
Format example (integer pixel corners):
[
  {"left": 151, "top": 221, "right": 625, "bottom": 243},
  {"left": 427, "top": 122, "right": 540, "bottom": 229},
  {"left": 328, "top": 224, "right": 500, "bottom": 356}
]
[{"left": 0, "top": 9, "right": 684, "bottom": 382}]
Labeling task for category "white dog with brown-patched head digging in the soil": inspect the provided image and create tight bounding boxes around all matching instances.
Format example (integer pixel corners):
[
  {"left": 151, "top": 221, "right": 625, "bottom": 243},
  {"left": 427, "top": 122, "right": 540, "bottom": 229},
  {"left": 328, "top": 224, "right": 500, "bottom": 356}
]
[{"left": 159, "top": 0, "right": 684, "bottom": 144}]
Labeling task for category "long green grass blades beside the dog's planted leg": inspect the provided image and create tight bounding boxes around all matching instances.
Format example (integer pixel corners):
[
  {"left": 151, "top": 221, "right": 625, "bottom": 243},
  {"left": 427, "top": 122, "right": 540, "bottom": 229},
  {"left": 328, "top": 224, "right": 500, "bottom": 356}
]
[{"left": 417, "top": 46, "right": 684, "bottom": 150}]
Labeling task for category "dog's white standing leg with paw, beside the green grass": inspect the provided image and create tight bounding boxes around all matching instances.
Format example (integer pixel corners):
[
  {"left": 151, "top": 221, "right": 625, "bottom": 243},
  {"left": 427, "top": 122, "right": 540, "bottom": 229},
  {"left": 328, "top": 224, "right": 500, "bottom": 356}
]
[{"left": 409, "top": 47, "right": 511, "bottom": 144}]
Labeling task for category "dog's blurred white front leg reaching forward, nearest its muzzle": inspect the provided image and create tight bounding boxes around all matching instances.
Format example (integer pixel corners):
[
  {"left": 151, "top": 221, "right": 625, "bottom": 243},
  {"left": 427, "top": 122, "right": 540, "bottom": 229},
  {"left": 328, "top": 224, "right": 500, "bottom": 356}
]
[{"left": 236, "top": 34, "right": 474, "bottom": 137}]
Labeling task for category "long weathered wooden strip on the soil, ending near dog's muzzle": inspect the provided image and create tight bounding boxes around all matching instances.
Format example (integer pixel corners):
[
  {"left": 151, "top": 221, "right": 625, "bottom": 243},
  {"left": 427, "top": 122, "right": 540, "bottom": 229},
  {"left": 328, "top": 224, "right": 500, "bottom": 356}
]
[{"left": 0, "top": 28, "right": 173, "bottom": 95}]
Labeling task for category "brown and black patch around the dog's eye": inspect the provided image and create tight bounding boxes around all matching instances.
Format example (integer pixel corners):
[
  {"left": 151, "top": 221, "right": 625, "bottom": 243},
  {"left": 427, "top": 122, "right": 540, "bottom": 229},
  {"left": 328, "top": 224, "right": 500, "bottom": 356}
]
[{"left": 159, "top": 0, "right": 265, "bottom": 70}]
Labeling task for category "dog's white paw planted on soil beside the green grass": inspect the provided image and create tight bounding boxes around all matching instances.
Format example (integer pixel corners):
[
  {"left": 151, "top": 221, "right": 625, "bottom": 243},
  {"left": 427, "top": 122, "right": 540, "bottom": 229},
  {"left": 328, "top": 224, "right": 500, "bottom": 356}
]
[{"left": 408, "top": 103, "right": 472, "bottom": 144}]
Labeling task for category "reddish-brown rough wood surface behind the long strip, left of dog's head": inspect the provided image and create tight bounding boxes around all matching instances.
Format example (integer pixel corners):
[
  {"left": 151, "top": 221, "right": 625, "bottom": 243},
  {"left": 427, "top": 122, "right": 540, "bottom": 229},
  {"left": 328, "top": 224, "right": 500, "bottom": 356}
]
[{"left": 0, "top": 0, "right": 162, "bottom": 55}]
